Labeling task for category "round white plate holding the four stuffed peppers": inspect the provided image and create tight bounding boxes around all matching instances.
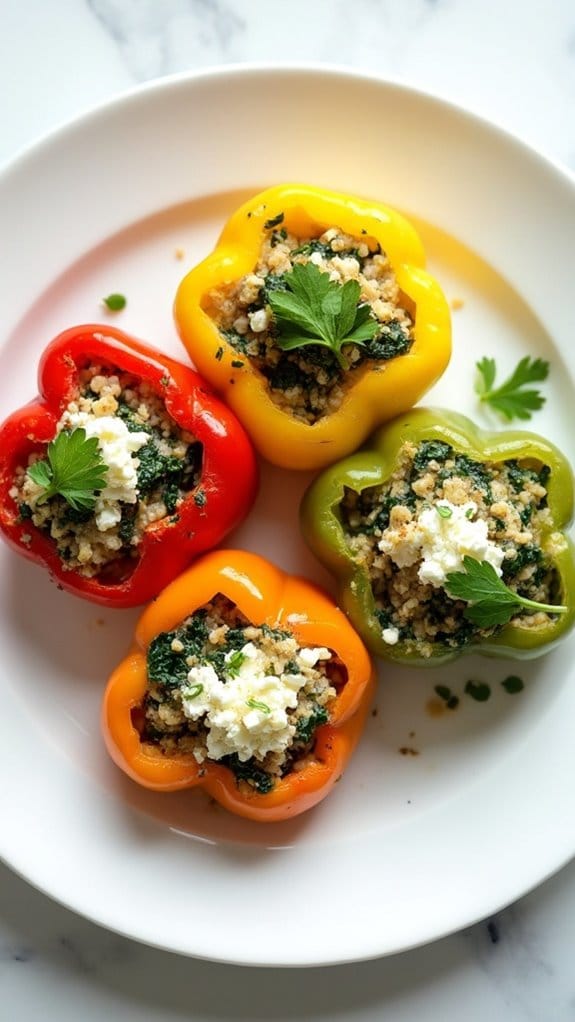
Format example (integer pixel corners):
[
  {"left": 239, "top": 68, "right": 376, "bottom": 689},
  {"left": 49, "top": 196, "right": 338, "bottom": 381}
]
[{"left": 0, "top": 68, "right": 575, "bottom": 965}]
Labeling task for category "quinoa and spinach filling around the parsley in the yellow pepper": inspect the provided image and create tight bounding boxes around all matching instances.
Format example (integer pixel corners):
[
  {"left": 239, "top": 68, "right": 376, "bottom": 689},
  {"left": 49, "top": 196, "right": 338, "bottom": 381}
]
[{"left": 205, "top": 221, "right": 414, "bottom": 425}]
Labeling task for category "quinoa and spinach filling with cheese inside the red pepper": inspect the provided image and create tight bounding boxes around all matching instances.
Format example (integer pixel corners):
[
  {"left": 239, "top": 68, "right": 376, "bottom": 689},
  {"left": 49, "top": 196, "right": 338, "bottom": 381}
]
[{"left": 10, "top": 365, "right": 202, "bottom": 580}]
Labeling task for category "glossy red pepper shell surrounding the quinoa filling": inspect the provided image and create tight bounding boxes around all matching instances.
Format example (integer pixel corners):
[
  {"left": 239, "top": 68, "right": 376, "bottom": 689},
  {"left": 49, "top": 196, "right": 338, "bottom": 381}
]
[{"left": 0, "top": 324, "right": 257, "bottom": 607}]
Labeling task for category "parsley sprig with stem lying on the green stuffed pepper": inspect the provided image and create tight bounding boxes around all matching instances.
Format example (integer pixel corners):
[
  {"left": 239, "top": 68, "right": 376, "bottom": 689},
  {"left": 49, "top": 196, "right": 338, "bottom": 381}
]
[{"left": 445, "top": 556, "right": 567, "bottom": 629}]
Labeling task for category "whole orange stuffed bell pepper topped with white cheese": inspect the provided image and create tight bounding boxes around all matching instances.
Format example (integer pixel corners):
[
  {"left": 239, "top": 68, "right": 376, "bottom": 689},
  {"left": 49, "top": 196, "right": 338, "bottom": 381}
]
[{"left": 103, "top": 551, "right": 373, "bottom": 821}]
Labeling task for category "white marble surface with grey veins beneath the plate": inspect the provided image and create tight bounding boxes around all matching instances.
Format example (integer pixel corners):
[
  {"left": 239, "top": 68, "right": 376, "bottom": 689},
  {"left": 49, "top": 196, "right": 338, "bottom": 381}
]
[{"left": 0, "top": 0, "right": 575, "bottom": 1022}]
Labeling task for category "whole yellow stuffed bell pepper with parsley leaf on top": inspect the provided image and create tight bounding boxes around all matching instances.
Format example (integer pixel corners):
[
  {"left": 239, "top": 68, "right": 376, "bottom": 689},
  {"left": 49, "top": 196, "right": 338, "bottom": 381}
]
[{"left": 175, "top": 184, "right": 450, "bottom": 469}]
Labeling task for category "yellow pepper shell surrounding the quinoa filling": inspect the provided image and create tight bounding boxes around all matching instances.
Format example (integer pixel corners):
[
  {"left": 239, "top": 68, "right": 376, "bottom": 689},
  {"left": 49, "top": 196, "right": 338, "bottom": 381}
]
[{"left": 175, "top": 184, "right": 450, "bottom": 469}]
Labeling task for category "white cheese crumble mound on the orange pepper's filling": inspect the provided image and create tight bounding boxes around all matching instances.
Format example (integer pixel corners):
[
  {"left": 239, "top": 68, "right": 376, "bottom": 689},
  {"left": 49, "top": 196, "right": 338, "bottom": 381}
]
[{"left": 182, "top": 642, "right": 331, "bottom": 762}]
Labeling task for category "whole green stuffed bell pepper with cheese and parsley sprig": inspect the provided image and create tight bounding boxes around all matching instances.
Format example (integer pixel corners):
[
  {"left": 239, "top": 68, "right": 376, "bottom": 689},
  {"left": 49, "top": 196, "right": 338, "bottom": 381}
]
[{"left": 301, "top": 408, "right": 575, "bottom": 665}]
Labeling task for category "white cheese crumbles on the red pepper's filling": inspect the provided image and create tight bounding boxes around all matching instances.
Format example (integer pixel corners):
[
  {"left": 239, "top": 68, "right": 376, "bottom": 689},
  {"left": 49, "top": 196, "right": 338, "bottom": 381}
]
[{"left": 59, "top": 411, "right": 150, "bottom": 532}]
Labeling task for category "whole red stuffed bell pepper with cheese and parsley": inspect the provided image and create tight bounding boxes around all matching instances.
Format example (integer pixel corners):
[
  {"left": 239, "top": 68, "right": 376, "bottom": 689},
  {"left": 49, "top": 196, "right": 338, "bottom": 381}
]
[{"left": 0, "top": 325, "right": 257, "bottom": 607}]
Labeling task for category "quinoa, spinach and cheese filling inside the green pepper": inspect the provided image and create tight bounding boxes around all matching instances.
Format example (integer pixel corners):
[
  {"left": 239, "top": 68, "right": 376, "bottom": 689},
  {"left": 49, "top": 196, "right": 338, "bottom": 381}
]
[{"left": 340, "top": 440, "right": 560, "bottom": 657}]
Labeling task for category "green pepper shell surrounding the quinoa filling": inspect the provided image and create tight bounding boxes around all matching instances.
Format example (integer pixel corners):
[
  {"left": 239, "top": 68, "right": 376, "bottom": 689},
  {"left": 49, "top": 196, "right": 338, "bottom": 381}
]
[{"left": 300, "top": 408, "right": 575, "bottom": 666}]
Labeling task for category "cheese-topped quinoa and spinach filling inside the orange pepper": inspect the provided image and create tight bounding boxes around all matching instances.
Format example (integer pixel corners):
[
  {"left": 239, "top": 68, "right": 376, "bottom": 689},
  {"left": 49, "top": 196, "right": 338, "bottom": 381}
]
[{"left": 134, "top": 594, "right": 337, "bottom": 793}]
